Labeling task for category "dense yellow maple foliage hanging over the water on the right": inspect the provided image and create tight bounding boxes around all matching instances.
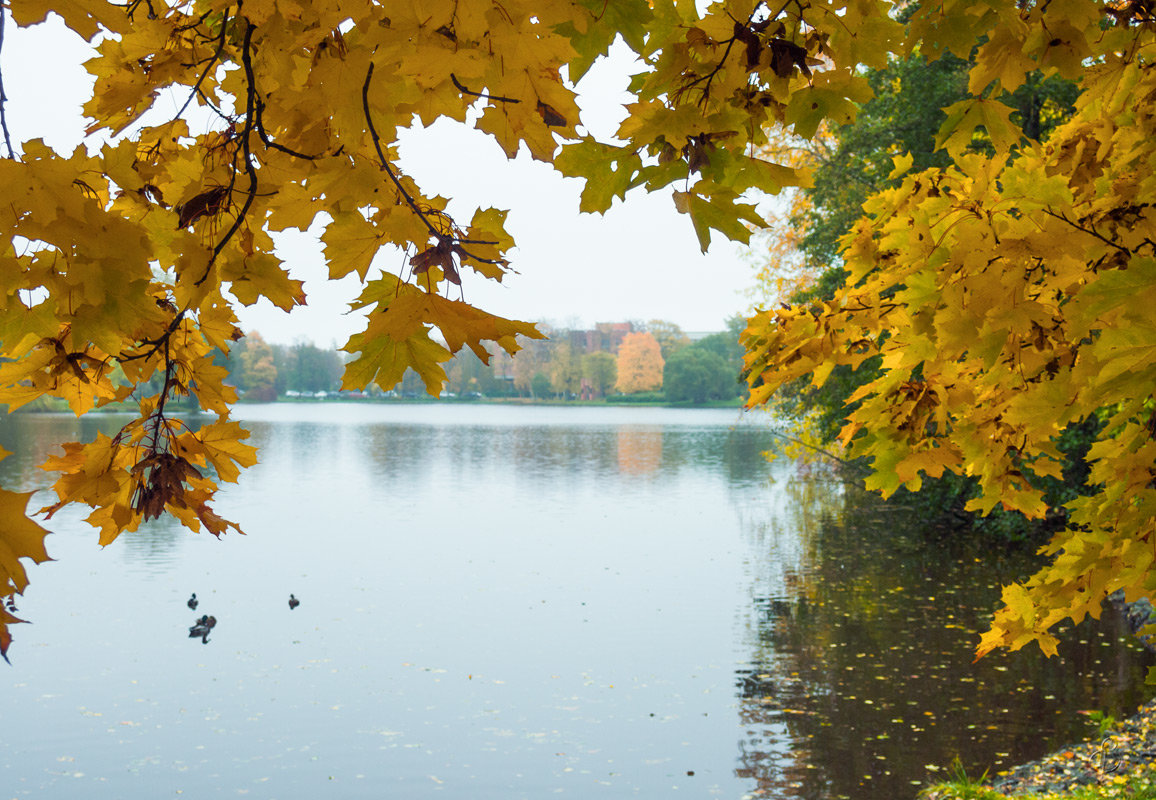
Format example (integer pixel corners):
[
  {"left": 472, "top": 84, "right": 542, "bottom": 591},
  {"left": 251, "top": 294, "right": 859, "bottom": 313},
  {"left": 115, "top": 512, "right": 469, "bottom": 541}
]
[{"left": 744, "top": 0, "right": 1156, "bottom": 655}]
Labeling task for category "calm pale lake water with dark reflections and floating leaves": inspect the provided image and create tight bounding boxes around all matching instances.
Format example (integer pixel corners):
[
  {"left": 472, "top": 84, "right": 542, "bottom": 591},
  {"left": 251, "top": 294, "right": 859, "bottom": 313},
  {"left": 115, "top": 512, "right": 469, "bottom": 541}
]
[{"left": 0, "top": 405, "right": 1149, "bottom": 800}]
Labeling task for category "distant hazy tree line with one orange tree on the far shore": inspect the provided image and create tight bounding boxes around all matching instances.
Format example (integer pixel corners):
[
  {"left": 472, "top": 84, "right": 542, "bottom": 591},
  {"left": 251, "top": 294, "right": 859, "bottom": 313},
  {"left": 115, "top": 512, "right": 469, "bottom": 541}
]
[{"left": 218, "top": 317, "right": 744, "bottom": 403}]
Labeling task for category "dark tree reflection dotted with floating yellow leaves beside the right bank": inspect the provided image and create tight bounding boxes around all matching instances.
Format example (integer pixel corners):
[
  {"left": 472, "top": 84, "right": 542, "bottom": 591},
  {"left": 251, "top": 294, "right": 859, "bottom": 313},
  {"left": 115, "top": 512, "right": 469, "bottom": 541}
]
[{"left": 736, "top": 480, "right": 1153, "bottom": 800}]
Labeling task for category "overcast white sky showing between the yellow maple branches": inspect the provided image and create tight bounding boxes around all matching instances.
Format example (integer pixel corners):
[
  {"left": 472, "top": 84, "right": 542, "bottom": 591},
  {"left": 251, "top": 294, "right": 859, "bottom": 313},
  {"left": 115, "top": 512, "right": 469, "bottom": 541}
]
[{"left": 0, "top": 16, "right": 754, "bottom": 346}]
